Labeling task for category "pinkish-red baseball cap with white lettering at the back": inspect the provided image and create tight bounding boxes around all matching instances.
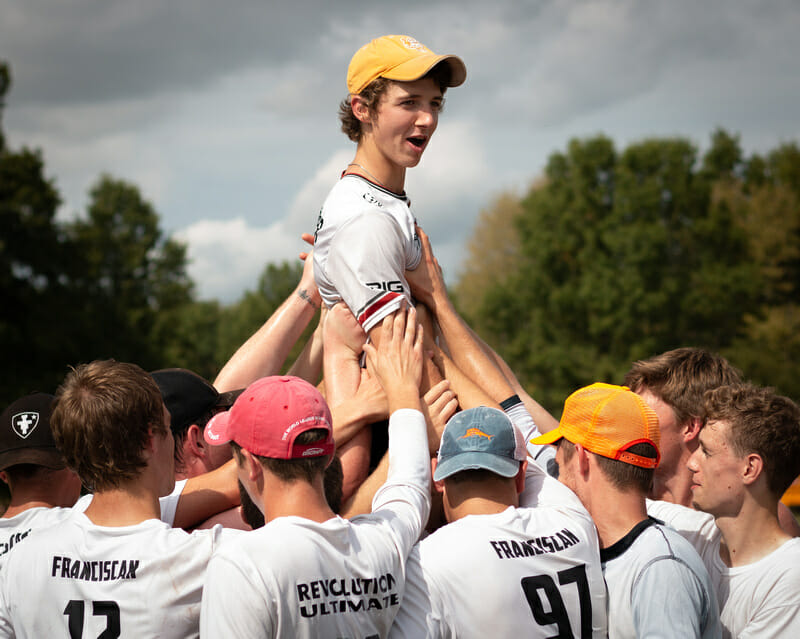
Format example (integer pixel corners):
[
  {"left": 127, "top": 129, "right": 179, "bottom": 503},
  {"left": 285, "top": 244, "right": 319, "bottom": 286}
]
[{"left": 204, "top": 375, "right": 335, "bottom": 459}]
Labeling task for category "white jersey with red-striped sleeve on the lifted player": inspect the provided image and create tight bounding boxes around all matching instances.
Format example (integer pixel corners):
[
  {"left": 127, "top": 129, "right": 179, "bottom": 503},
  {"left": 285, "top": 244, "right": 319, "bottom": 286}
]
[{"left": 313, "top": 174, "right": 422, "bottom": 332}]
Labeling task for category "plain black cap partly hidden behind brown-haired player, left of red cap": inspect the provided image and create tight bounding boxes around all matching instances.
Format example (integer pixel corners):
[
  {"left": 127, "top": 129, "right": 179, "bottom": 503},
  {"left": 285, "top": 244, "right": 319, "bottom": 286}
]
[{"left": 150, "top": 368, "right": 242, "bottom": 433}]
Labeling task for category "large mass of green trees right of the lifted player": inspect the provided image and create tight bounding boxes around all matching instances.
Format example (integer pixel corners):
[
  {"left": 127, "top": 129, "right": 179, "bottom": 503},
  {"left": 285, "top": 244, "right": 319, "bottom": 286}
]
[{"left": 455, "top": 129, "right": 800, "bottom": 411}]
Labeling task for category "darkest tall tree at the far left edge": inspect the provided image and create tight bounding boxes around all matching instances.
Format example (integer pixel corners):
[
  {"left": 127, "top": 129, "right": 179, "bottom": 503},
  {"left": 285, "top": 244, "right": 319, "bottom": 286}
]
[{"left": 0, "top": 62, "right": 86, "bottom": 403}]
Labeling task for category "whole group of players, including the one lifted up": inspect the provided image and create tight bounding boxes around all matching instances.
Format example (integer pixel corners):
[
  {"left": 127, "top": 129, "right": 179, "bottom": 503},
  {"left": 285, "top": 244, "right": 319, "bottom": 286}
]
[{"left": 0, "top": 36, "right": 800, "bottom": 639}]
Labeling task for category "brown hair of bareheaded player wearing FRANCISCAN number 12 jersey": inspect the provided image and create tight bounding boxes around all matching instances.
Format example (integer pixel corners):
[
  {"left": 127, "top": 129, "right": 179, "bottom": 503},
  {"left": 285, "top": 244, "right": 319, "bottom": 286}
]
[{"left": 50, "top": 360, "right": 167, "bottom": 491}]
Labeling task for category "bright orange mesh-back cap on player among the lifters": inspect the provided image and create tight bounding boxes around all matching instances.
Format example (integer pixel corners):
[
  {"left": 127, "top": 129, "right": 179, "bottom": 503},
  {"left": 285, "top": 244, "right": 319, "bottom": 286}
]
[{"left": 531, "top": 383, "right": 661, "bottom": 468}]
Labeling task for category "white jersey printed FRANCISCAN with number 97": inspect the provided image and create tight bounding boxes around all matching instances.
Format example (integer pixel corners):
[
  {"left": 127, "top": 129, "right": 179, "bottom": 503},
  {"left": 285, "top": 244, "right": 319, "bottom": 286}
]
[{"left": 390, "top": 462, "right": 606, "bottom": 639}]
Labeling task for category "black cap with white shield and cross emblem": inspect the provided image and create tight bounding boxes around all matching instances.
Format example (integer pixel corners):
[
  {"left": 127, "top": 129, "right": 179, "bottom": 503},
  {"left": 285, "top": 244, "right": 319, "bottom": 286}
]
[{"left": 0, "top": 393, "right": 66, "bottom": 470}]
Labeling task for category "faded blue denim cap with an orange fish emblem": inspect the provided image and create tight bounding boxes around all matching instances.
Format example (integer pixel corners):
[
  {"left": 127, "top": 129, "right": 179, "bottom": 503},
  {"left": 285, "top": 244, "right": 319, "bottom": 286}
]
[{"left": 433, "top": 406, "right": 527, "bottom": 481}]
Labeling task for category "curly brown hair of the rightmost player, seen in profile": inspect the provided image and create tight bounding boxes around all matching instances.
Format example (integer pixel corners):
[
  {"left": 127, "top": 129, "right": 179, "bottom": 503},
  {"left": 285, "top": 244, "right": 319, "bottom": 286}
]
[{"left": 705, "top": 384, "right": 800, "bottom": 497}]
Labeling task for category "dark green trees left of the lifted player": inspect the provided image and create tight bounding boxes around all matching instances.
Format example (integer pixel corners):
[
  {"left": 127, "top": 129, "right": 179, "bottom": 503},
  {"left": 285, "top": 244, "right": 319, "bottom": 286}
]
[{"left": 0, "top": 61, "right": 313, "bottom": 406}]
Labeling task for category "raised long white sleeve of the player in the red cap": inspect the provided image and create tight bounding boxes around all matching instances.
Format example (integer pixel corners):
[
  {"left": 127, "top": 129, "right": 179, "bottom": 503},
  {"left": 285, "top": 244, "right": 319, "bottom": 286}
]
[{"left": 372, "top": 409, "right": 431, "bottom": 557}]
